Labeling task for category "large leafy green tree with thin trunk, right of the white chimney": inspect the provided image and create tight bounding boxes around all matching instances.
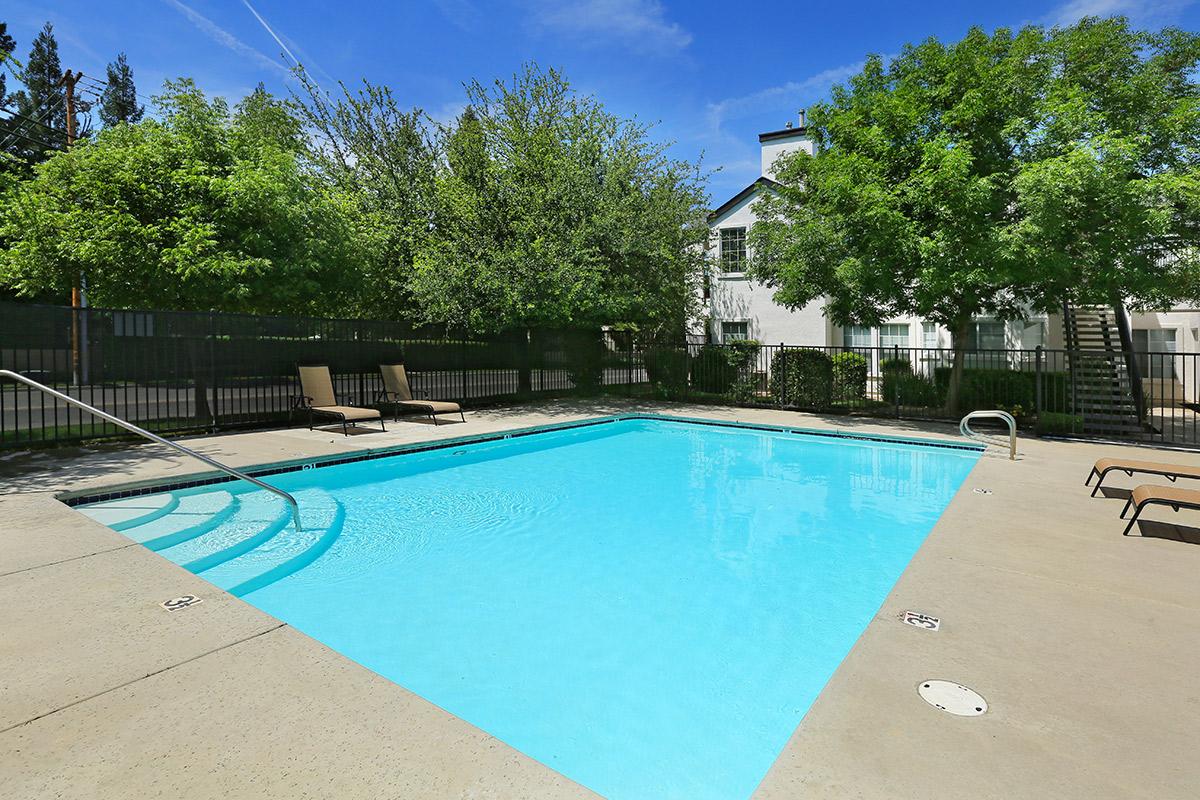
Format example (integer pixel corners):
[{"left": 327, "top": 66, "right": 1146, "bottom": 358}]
[{"left": 750, "top": 19, "right": 1196, "bottom": 411}]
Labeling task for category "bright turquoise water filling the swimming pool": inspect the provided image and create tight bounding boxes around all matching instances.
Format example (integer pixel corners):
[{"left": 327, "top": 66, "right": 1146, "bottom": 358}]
[{"left": 86, "top": 420, "right": 978, "bottom": 800}]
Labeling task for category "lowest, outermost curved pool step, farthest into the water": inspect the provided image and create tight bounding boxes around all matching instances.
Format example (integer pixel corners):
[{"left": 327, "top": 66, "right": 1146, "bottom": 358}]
[{"left": 200, "top": 489, "right": 346, "bottom": 597}]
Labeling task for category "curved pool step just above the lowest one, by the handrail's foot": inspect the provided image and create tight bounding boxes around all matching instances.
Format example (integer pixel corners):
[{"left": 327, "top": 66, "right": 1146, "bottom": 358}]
[{"left": 158, "top": 491, "right": 292, "bottom": 573}]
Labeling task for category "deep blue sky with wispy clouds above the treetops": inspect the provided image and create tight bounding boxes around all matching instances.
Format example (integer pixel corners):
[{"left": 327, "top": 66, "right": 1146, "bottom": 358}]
[{"left": 0, "top": 0, "right": 1200, "bottom": 205}]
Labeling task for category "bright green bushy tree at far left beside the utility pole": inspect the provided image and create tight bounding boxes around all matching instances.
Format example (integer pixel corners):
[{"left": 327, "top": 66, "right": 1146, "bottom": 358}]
[{"left": 0, "top": 80, "right": 358, "bottom": 313}]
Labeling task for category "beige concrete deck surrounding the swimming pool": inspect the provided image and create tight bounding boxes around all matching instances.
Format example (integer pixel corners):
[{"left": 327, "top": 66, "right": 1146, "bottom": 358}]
[{"left": 0, "top": 402, "right": 1200, "bottom": 800}]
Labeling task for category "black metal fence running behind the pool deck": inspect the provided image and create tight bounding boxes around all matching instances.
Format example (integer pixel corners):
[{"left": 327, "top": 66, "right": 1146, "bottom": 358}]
[{"left": 7, "top": 302, "right": 1200, "bottom": 447}]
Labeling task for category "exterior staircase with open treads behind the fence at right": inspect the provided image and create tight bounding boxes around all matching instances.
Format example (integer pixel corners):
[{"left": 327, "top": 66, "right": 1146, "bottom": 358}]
[{"left": 1062, "top": 305, "right": 1146, "bottom": 437}]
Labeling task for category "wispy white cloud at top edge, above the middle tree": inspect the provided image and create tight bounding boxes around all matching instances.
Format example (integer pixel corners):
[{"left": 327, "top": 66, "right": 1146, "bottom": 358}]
[{"left": 532, "top": 0, "right": 691, "bottom": 53}]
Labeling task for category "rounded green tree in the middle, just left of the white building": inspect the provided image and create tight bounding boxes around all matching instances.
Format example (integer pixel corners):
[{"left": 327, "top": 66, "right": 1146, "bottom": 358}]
[{"left": 412, "top": 66, "right": 707, "bottom": 333}]
